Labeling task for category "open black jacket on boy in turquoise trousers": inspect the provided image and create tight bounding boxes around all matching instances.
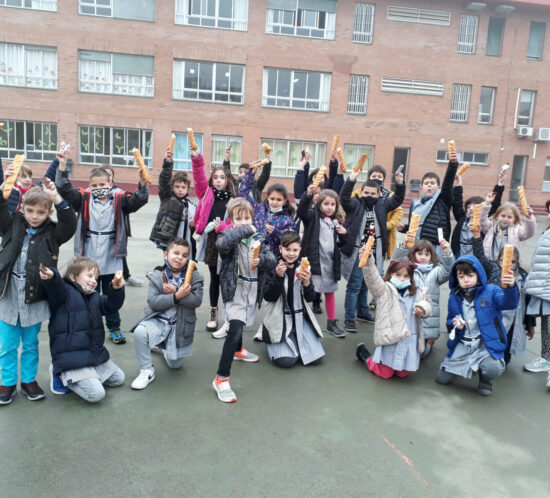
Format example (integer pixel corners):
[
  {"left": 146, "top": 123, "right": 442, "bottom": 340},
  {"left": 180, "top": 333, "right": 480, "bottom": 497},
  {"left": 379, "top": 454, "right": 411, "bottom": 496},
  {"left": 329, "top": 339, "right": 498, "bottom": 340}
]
[{"left": 0, "top": 195, "right": 76, "bottom": 304}]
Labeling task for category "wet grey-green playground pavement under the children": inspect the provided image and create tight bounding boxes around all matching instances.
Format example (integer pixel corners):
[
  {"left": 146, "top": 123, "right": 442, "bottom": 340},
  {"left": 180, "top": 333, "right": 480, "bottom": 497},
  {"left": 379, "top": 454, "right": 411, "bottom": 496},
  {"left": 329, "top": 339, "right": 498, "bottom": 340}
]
[{"left": 0, "top": 197, "right": 550, "bottom": 498}]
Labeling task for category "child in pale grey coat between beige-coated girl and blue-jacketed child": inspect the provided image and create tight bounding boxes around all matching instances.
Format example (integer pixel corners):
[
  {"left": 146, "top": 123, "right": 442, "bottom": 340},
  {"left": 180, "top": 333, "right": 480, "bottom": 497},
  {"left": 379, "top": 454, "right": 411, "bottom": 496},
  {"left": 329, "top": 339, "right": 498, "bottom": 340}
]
[{"left": 393, "top": 233, "right": 455, "bottom": 358}]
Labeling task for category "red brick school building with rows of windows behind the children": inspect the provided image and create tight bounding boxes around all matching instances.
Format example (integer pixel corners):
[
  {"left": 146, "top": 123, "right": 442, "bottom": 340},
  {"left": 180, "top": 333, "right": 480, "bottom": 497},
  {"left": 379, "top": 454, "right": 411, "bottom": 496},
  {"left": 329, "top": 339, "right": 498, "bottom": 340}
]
[{"left": 0, "top": 0, "right": 550, "bottom": 205}]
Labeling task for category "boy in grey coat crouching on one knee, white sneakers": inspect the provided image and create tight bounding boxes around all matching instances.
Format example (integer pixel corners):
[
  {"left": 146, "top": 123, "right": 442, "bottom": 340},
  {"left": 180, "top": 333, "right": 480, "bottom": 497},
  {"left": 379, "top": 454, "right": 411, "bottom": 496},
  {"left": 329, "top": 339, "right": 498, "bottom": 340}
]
[{"left": 132, "top": 238, "right": 203, "bottom": 389}]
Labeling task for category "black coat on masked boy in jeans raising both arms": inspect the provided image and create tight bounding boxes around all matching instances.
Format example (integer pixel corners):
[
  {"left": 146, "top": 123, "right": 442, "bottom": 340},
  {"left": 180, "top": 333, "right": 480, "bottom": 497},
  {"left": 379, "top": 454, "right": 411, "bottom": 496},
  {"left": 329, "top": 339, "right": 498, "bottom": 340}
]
[{"left": 341, "top": 178, "right": 406, "bottom": 256}]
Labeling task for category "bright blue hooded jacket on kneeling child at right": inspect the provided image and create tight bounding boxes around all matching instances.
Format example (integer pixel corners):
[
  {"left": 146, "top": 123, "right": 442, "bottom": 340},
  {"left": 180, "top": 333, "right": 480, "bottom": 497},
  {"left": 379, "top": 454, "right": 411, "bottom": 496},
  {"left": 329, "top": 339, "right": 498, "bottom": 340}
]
[{"left": 447, "top": 255, "right": 519, "bottom": 360}]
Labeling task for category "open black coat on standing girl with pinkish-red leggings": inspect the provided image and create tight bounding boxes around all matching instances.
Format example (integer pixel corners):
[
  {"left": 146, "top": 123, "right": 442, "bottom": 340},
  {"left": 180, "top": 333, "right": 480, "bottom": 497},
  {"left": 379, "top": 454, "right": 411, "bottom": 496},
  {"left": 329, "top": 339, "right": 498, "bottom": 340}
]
[{"left": 298, "top": 192, "right": 347, "bottom": 282}]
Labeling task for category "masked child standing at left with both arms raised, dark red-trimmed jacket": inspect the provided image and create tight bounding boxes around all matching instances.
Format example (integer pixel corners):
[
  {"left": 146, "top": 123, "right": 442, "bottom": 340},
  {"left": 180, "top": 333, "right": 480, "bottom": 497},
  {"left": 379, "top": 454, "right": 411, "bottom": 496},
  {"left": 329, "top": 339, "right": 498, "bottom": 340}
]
[{"left": 56, "top": 157, "right": 149, "bottom": 344}]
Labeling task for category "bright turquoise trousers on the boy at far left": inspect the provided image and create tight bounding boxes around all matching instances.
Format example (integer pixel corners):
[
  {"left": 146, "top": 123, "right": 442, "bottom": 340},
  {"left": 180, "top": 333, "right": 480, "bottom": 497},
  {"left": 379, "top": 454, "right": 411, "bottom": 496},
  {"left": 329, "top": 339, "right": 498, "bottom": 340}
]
[{"left": 0, "top": 320, "right": 41, "bottom": 386}]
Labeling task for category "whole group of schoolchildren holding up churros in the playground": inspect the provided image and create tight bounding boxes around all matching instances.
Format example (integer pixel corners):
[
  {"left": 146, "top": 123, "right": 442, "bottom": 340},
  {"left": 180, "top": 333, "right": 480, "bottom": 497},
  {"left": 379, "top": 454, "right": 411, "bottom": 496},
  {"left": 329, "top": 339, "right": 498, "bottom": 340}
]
[{"left": 0, "top": 142, "right": 550, "bottom": 404}]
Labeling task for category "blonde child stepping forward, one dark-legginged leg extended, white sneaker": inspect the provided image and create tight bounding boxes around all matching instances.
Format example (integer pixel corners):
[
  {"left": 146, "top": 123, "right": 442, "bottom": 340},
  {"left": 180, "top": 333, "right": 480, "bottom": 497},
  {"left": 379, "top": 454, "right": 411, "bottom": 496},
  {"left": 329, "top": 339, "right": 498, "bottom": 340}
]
[{"left": 212, "top": 197, "right": 276, "bottom": 403}]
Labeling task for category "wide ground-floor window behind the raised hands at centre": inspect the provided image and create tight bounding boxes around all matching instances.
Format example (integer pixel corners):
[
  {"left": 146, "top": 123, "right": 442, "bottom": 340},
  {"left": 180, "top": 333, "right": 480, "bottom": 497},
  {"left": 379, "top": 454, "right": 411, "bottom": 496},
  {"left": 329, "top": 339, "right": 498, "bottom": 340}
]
[{"left": 260, "top": 138, "right": 327, "bottom": 178}]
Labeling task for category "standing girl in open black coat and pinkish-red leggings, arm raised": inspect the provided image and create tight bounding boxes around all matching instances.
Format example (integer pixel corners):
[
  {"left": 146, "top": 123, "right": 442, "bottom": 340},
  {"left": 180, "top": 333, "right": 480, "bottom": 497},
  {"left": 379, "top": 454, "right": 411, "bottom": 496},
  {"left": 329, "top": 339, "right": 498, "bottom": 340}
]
[{"left": 298, "top": 189, "right": 347, "bottom": 338}]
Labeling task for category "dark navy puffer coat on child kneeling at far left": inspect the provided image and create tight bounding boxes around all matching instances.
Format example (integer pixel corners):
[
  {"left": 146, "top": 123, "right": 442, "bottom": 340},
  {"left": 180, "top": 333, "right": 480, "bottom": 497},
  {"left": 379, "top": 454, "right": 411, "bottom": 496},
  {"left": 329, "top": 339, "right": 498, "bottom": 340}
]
[{"left": 41, "top": 268, "right": 124, "bottom": 375}]
